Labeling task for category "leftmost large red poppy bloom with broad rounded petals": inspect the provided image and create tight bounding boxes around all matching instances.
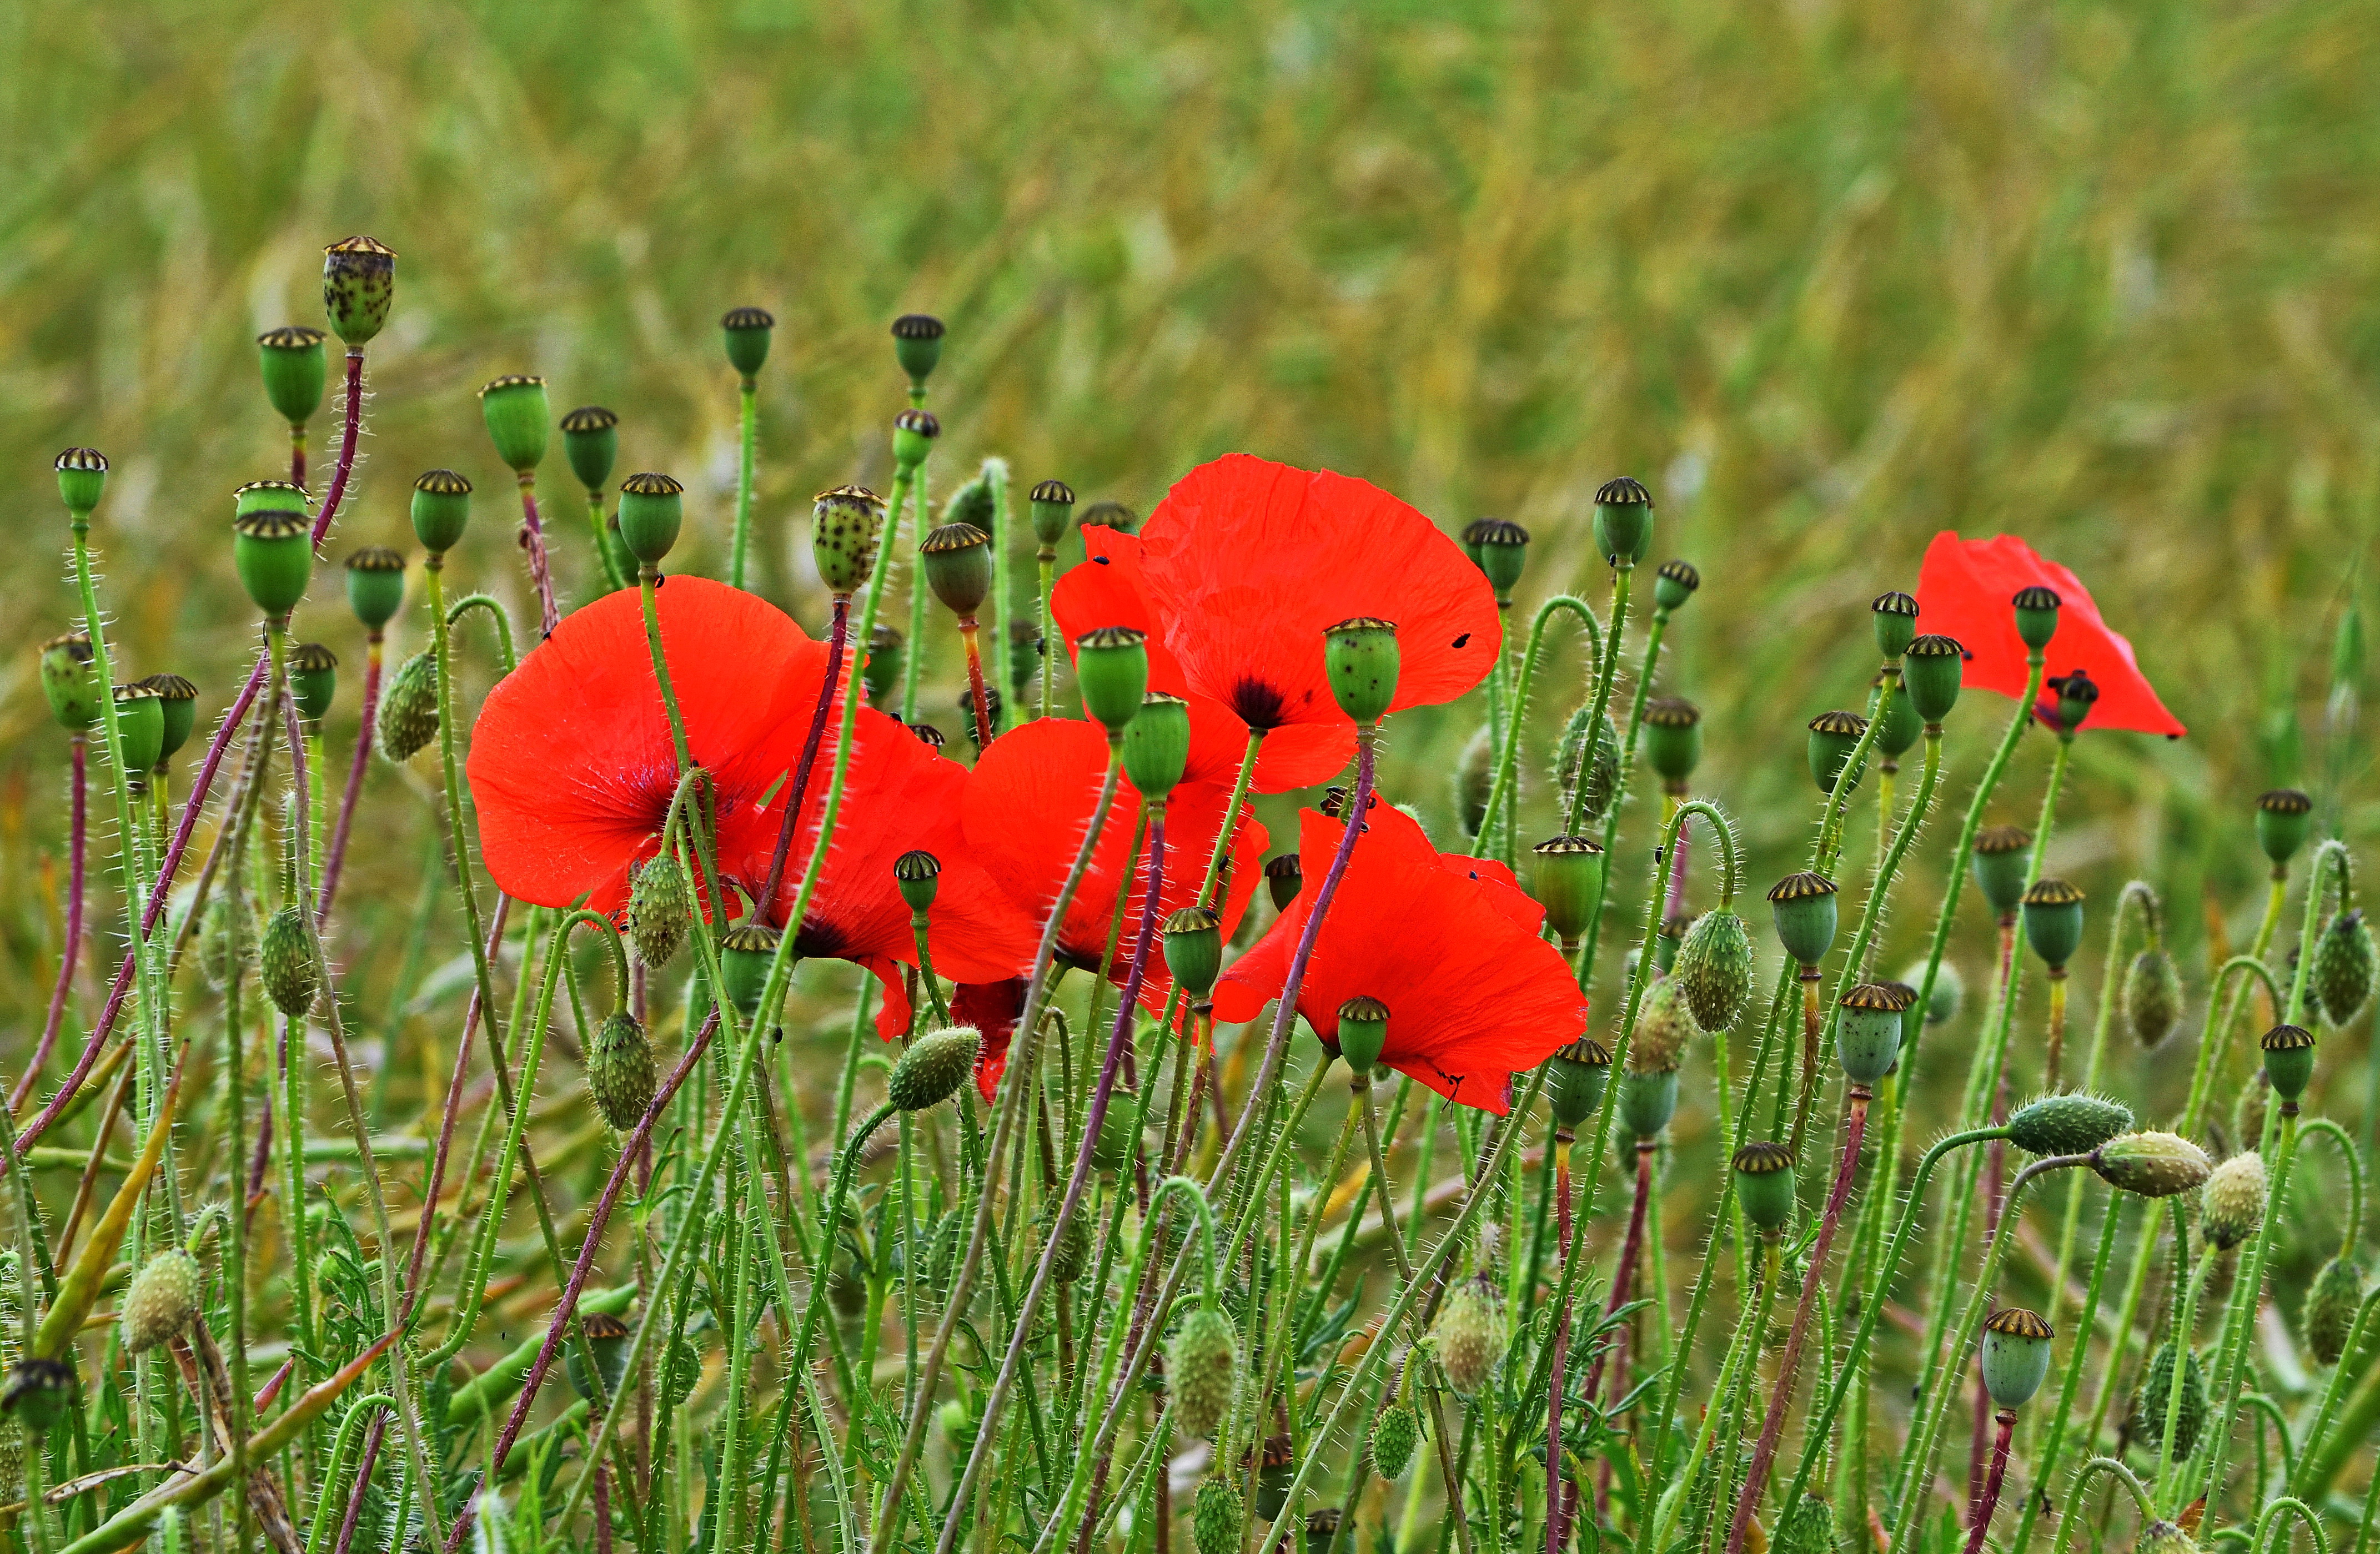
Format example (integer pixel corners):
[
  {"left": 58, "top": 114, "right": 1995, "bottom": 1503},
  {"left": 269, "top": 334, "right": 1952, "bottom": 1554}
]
[{"left": 469, "top": 574, "right": 826, "bottom": 912}]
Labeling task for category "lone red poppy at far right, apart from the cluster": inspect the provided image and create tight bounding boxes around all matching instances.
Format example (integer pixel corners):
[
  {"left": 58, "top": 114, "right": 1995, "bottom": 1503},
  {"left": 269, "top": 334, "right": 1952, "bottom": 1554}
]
[{"left": 1919, "top": 529, "right": 2190, "bottom": 738}]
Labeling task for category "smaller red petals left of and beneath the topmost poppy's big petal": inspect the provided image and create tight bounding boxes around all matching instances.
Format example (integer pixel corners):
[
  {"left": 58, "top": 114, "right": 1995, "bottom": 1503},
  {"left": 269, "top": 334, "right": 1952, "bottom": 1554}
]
[{"left": 1050, "top": 524, "right": 1354, "bottom": 792}]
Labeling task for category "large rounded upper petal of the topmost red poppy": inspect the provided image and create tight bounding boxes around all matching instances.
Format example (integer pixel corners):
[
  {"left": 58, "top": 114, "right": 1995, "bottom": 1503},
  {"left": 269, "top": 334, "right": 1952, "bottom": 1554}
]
[{"left": 1140, "top": 455, "right": 1502, "bottom": 731}]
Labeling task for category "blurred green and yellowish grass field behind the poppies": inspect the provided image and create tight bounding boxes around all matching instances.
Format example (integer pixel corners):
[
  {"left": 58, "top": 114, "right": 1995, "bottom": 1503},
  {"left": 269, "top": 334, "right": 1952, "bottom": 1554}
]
[{"left": 0, "top": 0, "right": 2380, "bottom": 1128}]
